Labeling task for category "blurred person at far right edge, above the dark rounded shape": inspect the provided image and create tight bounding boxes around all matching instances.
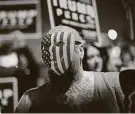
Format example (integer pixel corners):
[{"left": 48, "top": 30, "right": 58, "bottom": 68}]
[{"left": 120, "top": 45, "right": 135, "bottom": 71}]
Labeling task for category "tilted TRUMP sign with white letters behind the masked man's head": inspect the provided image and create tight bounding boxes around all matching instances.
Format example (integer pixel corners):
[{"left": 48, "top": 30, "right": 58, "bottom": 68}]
[{"left": 47, "top": 0, "right": 100, "bottom": 41}]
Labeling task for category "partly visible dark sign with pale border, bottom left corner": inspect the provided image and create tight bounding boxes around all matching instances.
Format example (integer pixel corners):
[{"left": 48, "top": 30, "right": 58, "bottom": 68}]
[{"left": 0, "top": 77, "right": 18, "bottom": 113}]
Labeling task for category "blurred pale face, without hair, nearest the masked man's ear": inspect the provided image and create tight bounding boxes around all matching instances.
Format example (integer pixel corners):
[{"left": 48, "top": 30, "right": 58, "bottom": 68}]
[{"left": 87, "top": 46, "right": 103, "bottom": 71}]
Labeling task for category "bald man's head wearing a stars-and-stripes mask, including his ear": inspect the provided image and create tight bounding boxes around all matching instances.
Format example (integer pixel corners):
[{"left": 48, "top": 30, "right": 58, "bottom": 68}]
[{"left": 41, "top": 26, "right": 83, "bottom": 75}]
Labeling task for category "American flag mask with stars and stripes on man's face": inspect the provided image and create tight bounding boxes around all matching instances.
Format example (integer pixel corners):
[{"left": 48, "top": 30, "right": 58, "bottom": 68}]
[{"left": 41, "top": 32, "right": 75, "bottom": 75}]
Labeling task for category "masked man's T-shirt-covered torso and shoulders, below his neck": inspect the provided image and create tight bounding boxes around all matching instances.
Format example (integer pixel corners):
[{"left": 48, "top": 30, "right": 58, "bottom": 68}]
[{"left": 16, "top": 72, "right": 124, "bottom": 113}]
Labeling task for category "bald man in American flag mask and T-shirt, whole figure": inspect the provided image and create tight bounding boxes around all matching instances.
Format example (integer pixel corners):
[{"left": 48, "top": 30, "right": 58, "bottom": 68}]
[{"left": 15, "top": 26, "right": 134, "bottom": 113}]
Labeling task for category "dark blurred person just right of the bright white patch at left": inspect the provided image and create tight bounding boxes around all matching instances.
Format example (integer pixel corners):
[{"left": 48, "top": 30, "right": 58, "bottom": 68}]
[{"left": 14, "top": 40, "right": 39, "bottom": 98}]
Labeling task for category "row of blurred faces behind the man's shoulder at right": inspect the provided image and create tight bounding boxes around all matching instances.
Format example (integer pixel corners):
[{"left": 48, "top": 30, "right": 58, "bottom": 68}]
[{"left": 83, "top": 43, "right": 135, "bottom": 72}]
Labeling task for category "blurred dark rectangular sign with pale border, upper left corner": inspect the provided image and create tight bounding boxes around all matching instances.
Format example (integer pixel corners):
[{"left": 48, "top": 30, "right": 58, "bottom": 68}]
[{"left": 0, "top": 0, "right": 41, "bottom": 39}]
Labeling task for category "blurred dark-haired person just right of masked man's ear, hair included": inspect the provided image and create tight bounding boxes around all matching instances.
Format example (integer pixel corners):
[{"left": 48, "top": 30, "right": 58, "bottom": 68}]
[{"left": 83, "top": 45, "right": 103, "bottom": 72}]
